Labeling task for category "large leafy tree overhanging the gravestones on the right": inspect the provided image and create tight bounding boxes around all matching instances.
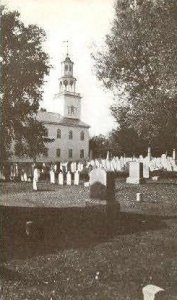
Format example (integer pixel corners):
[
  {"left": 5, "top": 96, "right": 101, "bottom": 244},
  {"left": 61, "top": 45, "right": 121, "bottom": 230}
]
[{"left": 93, "top": 0, "right": 177, "bottom": 151}]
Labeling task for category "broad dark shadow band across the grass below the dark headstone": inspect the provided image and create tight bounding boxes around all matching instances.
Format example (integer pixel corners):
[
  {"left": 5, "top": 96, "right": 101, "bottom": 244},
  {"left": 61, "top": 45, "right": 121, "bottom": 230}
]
[{"left": 0, "top": 206, "right": 174, "bottom": 262}]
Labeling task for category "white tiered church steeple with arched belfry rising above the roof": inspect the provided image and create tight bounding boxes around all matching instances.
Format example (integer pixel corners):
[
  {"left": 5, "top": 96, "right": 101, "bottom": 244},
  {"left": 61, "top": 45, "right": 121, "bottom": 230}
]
[{"left": 59, "top": 48, "right": 81, "bottom": 119}]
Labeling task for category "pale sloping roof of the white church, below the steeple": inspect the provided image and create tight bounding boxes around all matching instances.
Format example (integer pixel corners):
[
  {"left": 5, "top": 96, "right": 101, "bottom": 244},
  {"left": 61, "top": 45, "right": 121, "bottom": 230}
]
[{"left": 37, "top": 111, "right": 90, "bottom": 128}]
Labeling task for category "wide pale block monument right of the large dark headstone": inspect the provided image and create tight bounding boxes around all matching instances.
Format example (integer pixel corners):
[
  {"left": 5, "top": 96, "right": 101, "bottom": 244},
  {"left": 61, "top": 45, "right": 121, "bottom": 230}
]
[{"left": 126, "top": 161, "right": 144, "bottom": 184}]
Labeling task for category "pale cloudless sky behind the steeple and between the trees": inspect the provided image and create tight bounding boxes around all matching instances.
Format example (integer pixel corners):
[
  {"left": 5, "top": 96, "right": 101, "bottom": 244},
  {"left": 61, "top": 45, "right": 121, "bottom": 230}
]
[{"left": 1, "top": 0, "right": 115, "bottom": 136}]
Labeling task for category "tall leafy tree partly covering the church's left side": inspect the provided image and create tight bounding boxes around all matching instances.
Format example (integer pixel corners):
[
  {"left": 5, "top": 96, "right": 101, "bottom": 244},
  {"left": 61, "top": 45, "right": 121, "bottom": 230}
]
[{"left": 0, "top": 6, "right": 50, "bottom": 161}]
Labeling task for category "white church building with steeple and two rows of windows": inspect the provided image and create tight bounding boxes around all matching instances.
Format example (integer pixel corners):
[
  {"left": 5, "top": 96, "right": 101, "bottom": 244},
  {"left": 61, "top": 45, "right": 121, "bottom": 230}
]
[{"left": 11, "top": 54, "right": 90, "bottom": 163}]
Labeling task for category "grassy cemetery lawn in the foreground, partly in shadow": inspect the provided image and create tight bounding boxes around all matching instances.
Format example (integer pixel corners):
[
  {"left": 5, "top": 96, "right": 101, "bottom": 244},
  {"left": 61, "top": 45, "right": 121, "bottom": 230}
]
[{"left": 0, "top": 179, "right": 177, "bottom": 300}]
